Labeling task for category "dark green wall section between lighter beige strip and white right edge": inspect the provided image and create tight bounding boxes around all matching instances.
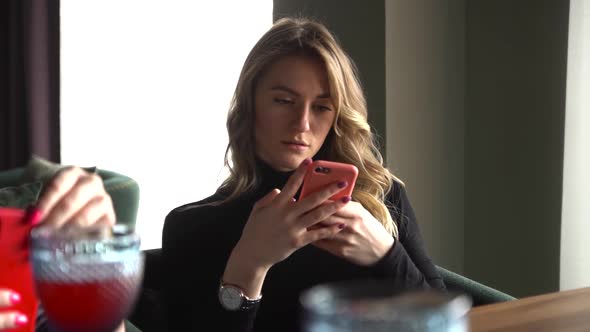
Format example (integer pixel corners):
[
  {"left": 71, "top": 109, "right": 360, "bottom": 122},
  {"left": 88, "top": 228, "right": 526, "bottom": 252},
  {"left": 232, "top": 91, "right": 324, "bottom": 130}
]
[{"left": 465, "top": 0, "right": 569, "bottom": 296}]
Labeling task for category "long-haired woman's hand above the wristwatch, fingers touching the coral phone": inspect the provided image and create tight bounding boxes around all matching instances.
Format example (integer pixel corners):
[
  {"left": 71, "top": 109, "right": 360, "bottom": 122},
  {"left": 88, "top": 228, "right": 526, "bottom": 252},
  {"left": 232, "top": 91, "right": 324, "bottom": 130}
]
[{"left": 222, "top": 159, "right": 348, "bottom": 297}]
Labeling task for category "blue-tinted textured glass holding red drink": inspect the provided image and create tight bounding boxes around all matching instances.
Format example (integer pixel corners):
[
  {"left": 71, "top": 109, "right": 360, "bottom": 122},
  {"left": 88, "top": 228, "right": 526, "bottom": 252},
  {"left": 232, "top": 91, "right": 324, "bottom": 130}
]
[{"left": 31, "top": 225, "right": 145, "bottom": 332}]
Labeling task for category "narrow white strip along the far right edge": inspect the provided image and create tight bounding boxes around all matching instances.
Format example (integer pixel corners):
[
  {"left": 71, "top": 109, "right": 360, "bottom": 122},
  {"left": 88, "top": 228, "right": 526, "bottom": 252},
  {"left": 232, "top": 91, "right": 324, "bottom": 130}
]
[{"left": 560, "top": 0, "right": 590, "bottom": 290}]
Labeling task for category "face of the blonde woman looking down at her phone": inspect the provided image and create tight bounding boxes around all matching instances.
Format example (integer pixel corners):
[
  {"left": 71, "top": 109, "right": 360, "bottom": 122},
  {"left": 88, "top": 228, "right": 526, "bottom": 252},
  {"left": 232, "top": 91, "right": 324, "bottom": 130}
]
[{"left": 254, "top": 56, "right": 336, "bottom": 171}]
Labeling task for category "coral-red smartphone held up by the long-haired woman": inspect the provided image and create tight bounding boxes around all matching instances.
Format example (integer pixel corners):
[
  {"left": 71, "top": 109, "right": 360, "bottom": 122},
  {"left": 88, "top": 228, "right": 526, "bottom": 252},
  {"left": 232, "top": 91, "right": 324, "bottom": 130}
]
[{"left": 299, "top": 160, "right": 358, "bottom": 201}]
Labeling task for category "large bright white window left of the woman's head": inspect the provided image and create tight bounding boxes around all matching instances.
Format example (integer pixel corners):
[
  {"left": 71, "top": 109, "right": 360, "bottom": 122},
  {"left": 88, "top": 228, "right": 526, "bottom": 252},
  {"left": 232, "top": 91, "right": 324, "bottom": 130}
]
[{"left": 61, "top": 0, "right": 272, "bottom": 249}]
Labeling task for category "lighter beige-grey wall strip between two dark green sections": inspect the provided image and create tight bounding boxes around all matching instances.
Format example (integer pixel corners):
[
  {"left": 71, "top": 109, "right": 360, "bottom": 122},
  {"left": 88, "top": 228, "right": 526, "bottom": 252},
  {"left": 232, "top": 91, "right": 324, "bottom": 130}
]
[{"left": 385, "top": 0, "right": 465, "bottom": 273}]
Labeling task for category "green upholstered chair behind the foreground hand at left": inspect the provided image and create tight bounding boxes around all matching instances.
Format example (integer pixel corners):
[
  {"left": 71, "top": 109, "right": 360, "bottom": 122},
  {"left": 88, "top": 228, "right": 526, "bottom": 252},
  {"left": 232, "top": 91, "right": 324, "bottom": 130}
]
[{"left": 0, "top": 167, "right": 139, "bottom": 227}]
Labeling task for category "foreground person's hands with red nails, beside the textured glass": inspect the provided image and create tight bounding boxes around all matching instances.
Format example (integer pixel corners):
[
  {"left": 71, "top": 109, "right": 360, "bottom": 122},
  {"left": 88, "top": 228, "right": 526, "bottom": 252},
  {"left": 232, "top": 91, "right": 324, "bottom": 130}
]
[{"left": 0, "top": 167, "right": 125, "bottom": 332}]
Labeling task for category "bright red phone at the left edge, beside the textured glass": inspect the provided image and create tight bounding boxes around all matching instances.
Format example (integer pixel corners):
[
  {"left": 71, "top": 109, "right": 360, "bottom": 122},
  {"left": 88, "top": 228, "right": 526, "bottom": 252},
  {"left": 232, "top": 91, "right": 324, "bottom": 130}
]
[{"left": 0, "top": 208, "right": 37, "bottom": 332}]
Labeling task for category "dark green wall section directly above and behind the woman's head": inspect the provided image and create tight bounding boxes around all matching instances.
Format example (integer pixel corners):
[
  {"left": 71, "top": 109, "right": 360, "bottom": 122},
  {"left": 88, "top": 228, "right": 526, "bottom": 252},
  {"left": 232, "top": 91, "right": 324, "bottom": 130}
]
[{"left": 273, "top": 0, "right": 385, "bottom": 157}]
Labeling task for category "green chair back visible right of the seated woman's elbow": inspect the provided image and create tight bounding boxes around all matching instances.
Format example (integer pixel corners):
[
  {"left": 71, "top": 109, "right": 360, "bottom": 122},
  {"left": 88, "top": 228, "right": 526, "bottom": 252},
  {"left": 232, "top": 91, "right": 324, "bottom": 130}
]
[{"left": 436, "top": 266, "right": 516, "bottom": 306}]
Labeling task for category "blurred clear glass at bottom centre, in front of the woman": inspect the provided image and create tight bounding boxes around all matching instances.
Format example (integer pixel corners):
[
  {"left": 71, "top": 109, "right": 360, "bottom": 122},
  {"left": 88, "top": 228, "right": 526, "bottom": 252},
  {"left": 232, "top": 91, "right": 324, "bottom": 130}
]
[{"left": 300, "top": 280, "right": 472, "bottom": 332}]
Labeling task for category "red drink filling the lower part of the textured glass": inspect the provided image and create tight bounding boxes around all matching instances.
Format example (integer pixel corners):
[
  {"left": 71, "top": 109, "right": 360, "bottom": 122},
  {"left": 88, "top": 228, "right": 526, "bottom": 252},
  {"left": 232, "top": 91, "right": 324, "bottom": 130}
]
[{"left": 37, "top": 276, "right": 137, "bottom": 332}]
